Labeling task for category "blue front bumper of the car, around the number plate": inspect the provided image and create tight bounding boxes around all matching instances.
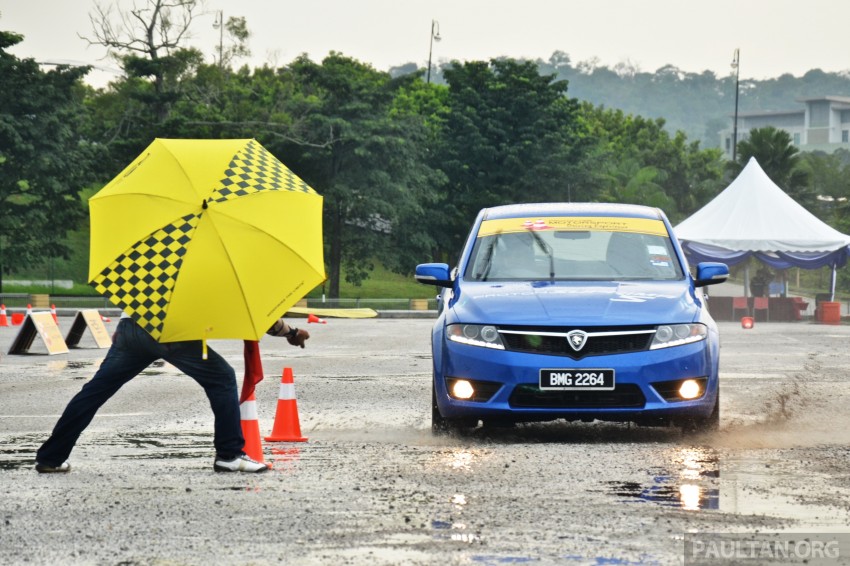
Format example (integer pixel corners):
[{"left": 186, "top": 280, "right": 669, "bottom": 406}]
[{"left": 434, "top": 341, "right": 718, "bottom": 422}]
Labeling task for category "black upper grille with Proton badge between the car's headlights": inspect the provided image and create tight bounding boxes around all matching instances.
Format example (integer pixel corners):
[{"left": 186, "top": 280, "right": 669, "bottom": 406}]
[{"left": 501, "top": 326, "right": 655, "bottom": 360}]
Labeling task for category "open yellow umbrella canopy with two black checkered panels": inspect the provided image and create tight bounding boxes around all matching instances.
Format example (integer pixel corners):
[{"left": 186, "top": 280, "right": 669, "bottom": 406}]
[{"left": 89, "top": 139, "right": 325, "bottom": 342}]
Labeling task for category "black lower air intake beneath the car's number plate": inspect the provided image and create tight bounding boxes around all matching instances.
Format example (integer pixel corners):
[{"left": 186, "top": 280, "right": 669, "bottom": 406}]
[{"left": 509, "top": 383, "right": 646, "bottom": 409}]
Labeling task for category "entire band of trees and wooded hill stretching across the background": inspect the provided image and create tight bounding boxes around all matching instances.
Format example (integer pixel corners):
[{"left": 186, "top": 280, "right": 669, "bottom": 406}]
[{"left": 13, "top": 7, "right": 850, "bottom": 297}]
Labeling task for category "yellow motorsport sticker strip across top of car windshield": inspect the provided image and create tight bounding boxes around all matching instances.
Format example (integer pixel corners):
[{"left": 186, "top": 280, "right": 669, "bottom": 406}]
[{"left": 478, "top": 216, "right": 667, "bottom": 238}]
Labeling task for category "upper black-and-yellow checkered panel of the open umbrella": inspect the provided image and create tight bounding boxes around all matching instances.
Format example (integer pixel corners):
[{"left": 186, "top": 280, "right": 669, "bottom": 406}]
[{"left": 209, "top": 140, "right": 316, "bottom": 202}]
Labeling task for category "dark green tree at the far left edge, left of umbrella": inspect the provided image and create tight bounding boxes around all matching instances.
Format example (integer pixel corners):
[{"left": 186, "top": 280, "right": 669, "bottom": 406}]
[{"left": 0, "top": 32, "right": 98, "bottom": 290}]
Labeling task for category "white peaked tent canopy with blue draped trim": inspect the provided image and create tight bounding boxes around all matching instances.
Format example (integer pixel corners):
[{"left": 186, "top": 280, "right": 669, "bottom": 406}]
[{"left": 673, "top": 157, "right": 850, "bottom": 269}]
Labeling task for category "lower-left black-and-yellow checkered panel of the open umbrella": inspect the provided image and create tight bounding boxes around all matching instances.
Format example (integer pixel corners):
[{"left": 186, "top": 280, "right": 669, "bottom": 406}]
[{"left": 91, "top": 214, "right": 200, "bottom": 339}]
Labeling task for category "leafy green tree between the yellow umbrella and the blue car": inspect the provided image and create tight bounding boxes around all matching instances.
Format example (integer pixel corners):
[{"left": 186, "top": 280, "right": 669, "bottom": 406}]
[{"left": 266, "top": 53, "right": 439, "bottom": 297}]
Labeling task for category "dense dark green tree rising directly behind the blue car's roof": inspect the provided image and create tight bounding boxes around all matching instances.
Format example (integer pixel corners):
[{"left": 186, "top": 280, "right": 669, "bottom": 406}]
[{"left": 435, "top": 59, "right": 584, "bottom": 251}]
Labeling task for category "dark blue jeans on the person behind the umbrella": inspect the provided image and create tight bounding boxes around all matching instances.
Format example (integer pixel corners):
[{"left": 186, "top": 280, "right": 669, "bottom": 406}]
[{"left": 36, "top": 318, "right": 245, "bottom": 466}]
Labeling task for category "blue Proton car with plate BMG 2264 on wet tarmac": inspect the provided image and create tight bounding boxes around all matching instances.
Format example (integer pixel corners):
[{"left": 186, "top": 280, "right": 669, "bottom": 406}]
[{"left": 416, "top": 203, "right": 729, "bottom": 433}]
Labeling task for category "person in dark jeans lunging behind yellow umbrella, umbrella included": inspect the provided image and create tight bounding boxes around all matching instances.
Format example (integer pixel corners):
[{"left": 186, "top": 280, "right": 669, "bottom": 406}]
[{"left": 36, "top": 138, "right": 326, "bottom": 473}]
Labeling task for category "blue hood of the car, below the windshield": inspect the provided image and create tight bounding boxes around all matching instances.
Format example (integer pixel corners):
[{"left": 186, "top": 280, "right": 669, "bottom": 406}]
[{"left": 447, "top": 281, "right": 700, "bottom": 326}]
